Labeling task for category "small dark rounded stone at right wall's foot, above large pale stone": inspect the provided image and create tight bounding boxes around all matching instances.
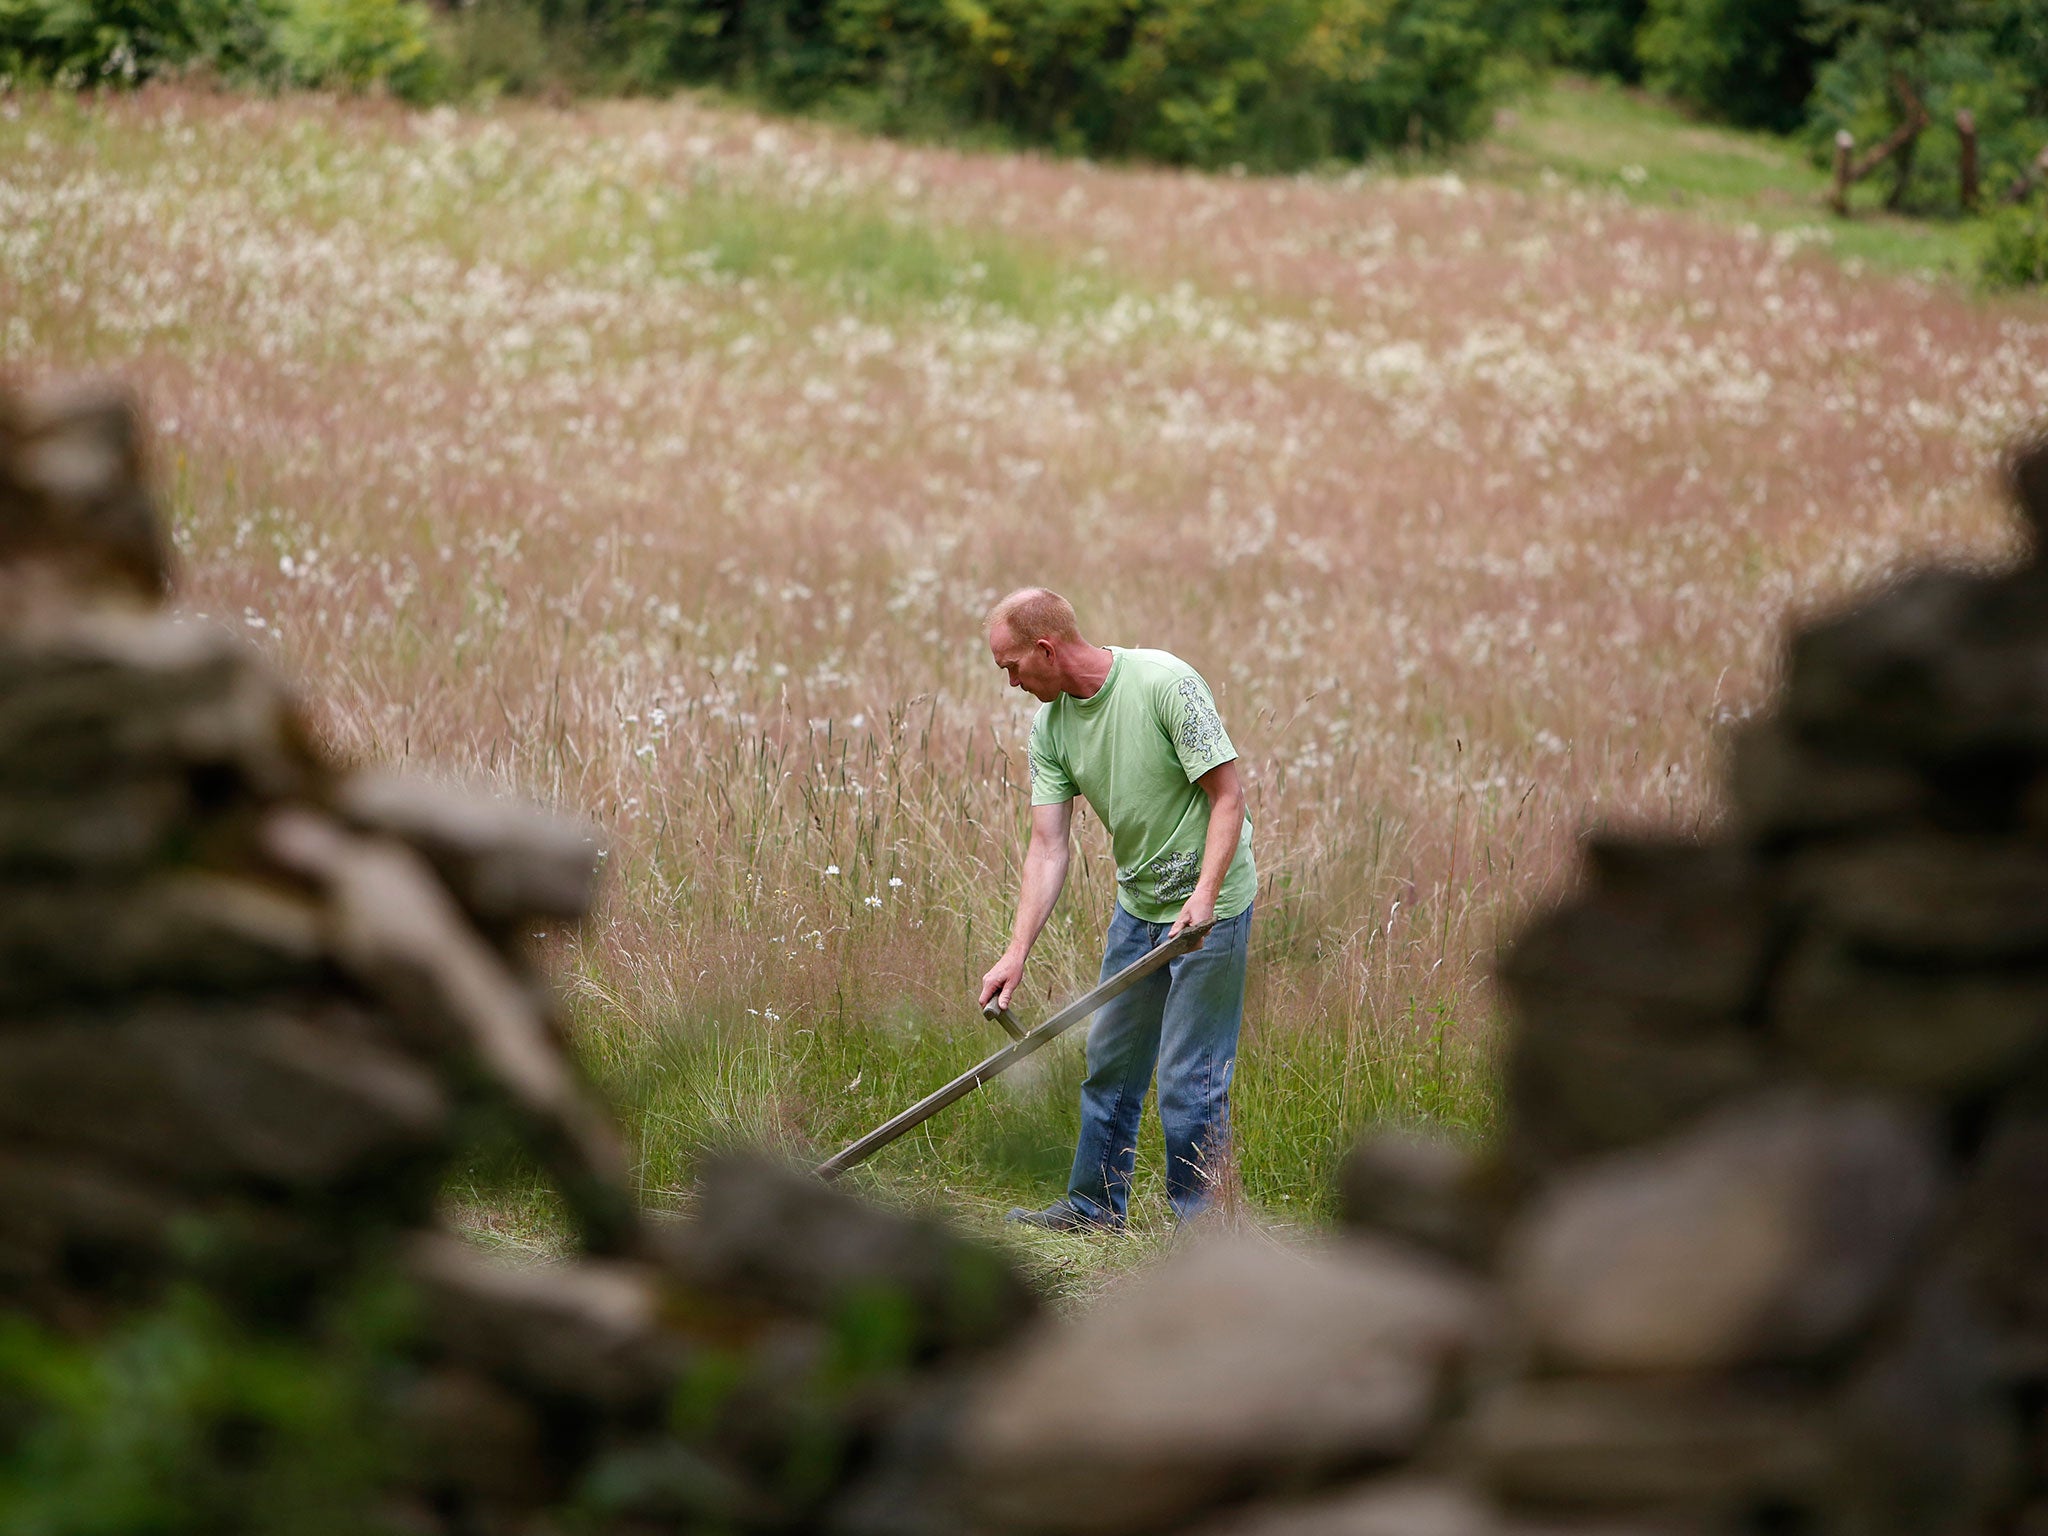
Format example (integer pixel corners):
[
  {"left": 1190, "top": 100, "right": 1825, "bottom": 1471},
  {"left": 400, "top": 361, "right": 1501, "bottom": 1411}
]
[{"left": 1337, "top": 1128, "right": 1497, "bottom": 1264}]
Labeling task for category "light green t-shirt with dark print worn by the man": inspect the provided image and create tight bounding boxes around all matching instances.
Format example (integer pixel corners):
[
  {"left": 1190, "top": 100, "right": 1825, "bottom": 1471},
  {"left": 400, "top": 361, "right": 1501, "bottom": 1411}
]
[{"left": 1030, "top": 645, "right": 1260, "bottom": 924}]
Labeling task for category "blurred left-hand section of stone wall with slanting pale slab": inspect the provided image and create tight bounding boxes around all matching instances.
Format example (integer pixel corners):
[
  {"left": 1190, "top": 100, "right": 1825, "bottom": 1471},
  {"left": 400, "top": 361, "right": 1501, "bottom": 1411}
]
[{"left": 0, "top": 376, "right": 1032, "bottom": 1536}]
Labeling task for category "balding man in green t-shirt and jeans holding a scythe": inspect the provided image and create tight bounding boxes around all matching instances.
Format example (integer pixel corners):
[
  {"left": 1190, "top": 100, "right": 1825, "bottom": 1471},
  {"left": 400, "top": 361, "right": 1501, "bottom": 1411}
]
[{"left": 981, "top": 588, "right": 1257, "bottom": 1231}]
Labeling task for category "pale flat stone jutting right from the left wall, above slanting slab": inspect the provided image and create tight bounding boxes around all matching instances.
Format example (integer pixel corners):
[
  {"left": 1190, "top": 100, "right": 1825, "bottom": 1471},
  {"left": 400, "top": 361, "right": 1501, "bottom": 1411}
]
[{"left": 338, "top": 774, "right": 602, "bottom": 926}]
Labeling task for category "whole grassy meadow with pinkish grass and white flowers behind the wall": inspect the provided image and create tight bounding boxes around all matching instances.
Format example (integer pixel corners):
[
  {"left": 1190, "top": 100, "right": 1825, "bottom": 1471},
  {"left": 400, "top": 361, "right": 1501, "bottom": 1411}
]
[{"left": 0, "top": 78, "right": 2048, "bottom": 1288}]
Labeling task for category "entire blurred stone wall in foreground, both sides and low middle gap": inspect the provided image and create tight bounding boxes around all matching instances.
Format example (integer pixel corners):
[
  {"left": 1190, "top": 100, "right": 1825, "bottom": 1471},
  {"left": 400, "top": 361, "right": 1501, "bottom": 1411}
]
[{"left": 12, "top": 376, "right": 2048, "bottom": 1536}]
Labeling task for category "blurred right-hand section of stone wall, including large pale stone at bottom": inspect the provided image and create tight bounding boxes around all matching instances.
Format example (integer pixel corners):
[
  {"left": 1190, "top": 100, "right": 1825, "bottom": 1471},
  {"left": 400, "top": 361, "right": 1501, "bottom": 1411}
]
[{"left": 961, "top": 444, "right": 2048, "bottom": 1536}]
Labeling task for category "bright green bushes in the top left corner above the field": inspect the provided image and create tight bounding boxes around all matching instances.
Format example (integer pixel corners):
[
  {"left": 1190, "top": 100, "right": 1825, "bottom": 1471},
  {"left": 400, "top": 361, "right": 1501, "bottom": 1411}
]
[{"left": 0, "top": 0, "right": 438, "bottom": 98}]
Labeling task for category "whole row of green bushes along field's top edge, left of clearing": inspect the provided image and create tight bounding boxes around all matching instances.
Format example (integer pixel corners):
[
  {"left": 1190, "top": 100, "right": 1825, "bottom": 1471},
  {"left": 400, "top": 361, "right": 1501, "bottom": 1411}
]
[{"left": 0, "top": 0, "right": 1505, "bottom": 170}]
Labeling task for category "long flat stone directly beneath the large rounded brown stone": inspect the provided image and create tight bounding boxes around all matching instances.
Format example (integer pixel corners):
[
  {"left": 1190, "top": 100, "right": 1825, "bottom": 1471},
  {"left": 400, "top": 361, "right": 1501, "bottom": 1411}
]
[{"left": 1464, "top": 1376, "right": 1837, "bottom": 1520}]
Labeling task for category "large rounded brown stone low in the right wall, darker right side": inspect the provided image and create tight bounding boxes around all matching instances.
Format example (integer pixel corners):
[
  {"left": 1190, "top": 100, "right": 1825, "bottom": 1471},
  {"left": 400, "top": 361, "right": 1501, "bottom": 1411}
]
[{"left": 1505, "top": 1090, "right": 1942, "bottom": 1374}]
